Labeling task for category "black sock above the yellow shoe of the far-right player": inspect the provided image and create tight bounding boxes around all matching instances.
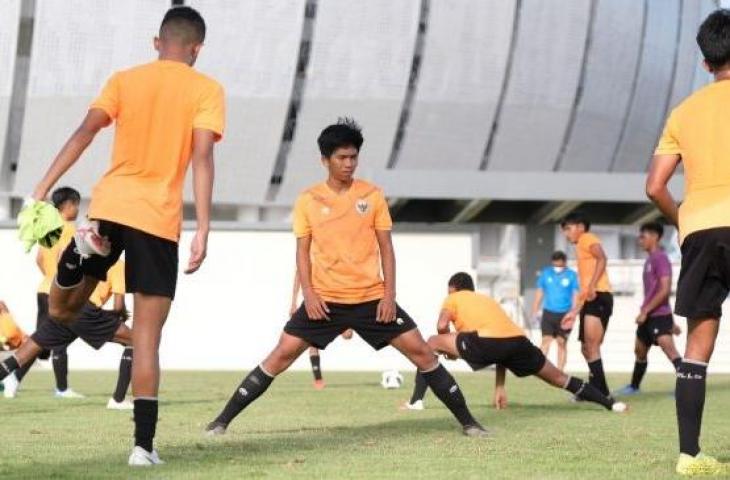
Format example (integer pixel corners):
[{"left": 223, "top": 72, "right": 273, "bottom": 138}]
[{"left": 675, "top": 360, "right": 707, "bottom": 457}]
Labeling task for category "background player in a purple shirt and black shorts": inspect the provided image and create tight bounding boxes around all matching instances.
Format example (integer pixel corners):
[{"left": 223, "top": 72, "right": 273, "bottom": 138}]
[{"left": 616, "top": 222, "right": 682, "bottom": 395}]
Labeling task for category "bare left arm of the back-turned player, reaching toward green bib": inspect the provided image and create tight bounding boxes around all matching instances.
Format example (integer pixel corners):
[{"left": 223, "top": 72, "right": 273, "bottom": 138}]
[{"left": 33, "top": 108, "right": 111, "bottom": 200}]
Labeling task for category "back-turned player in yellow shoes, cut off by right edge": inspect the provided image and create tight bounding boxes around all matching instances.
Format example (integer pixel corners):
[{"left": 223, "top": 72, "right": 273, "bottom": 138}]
[{"left": 637, "top": 9, "right": 730, "bottom": 475}]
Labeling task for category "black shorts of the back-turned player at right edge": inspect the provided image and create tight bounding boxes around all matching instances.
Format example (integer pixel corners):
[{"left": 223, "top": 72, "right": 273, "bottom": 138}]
[{"left": 674, "top": 227, "right": 730, "bottom": 320}]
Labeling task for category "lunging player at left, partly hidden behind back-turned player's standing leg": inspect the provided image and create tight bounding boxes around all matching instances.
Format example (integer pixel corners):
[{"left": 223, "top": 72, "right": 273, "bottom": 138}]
[{"left": 0, "top": 261, "right": 132, "bottom": 410}]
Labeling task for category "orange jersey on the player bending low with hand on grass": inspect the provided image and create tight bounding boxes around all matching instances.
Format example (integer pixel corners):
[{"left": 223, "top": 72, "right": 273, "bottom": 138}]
[{"left": 441, "top": 290, "right": 525, "bottom": 338}]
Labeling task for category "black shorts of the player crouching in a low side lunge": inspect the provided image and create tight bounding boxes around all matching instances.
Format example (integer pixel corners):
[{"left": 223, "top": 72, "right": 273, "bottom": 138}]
[{"left": 456, "top": 332, "right": 547, "bottom": 377}]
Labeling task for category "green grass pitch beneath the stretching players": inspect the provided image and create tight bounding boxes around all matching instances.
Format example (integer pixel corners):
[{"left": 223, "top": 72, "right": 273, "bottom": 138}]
[{"left": 0, "top": 372, "right": 730, "bottom": 480}]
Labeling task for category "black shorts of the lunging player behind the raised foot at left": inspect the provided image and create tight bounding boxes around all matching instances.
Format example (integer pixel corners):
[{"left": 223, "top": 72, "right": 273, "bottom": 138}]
[{"left": 30, "top": 302, "right": 123, "bottom": 350}]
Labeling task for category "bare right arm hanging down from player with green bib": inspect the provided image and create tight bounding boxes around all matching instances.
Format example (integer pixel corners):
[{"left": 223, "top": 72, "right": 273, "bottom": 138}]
[{"left": 185, "top": 128, "right": 216, "bottom": 274}]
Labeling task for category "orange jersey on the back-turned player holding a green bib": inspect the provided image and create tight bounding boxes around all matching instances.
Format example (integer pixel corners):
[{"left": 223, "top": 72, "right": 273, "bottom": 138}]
[{"left": 89, "top": 60, "right": 225, "bottom": 242}]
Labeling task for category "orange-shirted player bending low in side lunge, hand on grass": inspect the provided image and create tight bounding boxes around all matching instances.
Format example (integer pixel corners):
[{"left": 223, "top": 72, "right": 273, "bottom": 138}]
[{"left": 410, "top": 272, "right": 628, "bottom": 413}]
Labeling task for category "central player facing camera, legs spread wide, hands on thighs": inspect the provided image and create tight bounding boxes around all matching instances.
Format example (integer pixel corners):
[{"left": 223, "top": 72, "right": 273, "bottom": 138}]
[{"left": 206, "top": 119, "right": 486, "bottom": 436}]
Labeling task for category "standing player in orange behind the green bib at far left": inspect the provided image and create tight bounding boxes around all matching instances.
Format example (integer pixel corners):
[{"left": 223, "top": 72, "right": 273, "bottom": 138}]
[{"left": 36, "top": 187, "right": 84, "bottom": 398}]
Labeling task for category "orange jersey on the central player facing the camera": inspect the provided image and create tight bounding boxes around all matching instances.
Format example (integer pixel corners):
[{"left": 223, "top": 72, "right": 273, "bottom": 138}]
[{"left": 293, "top": 180, "right": 393, "bottom": 304}]
